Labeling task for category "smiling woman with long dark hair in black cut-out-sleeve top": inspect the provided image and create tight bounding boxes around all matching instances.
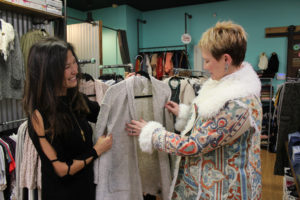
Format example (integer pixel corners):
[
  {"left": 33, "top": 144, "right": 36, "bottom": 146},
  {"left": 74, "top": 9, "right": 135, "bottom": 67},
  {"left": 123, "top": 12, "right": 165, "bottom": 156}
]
[{"left": 23, "top": 38, "right": 112, "bottom": 200}]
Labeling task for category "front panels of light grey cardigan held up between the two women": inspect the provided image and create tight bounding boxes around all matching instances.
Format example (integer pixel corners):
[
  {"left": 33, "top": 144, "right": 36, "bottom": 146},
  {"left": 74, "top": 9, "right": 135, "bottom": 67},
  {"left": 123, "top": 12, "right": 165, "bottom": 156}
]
[{"left": 94, "top": 76, "right": 174, "bottom": 200}]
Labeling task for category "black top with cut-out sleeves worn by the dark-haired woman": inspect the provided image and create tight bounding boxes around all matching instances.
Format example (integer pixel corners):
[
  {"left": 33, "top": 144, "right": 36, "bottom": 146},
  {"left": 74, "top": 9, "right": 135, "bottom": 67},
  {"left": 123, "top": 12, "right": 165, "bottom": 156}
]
[{"left": 28, "top": 96, "right": 100, "bottom": 200}]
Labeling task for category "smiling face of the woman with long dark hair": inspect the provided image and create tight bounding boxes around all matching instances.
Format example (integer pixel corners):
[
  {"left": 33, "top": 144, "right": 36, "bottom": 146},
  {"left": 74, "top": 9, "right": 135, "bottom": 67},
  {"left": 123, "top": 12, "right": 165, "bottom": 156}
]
[{"left": 63, "top": 50, "right": 78, "bottom": 94}]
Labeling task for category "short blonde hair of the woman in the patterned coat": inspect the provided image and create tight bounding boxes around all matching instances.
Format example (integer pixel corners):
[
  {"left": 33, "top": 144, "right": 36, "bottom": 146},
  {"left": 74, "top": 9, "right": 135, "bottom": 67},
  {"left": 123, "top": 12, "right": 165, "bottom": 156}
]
[{"left": 198, "top": 21, "right": 247, "bottom": 66}]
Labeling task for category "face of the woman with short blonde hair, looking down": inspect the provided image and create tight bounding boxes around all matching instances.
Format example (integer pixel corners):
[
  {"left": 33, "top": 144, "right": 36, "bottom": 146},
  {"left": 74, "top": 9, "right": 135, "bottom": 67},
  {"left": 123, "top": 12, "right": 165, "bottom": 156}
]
[{"left": 201, "top": 49, "right": 227, "bottom": 80}]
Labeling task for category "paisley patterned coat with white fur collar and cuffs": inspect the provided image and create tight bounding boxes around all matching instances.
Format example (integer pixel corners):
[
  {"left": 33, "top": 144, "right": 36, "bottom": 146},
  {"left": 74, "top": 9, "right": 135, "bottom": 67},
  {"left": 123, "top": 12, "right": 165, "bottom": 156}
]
[{"left": 139, "top": 62, "right": 262, "bottom": 200}]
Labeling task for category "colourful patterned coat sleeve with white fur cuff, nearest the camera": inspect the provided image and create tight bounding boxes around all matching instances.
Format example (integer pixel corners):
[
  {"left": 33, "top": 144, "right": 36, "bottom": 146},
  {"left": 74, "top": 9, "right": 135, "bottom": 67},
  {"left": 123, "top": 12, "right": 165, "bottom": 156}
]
[{"left": 139, "top": 101, "right": 251, "bottom": 156}]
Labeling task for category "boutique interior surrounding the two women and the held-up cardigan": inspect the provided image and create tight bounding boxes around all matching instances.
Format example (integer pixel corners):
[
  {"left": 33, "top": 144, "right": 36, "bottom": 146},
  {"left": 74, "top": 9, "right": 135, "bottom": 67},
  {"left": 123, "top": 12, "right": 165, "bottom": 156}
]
[{"left": 0, "top": 0, "right": 300, "bottom": 200}]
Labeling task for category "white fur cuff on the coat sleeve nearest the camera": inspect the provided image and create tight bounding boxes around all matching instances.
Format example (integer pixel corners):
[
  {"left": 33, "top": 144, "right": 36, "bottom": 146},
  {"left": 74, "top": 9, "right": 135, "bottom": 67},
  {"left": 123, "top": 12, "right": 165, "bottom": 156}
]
[{"left": 139, "top": 121, "right": 164, "bottom": 153}]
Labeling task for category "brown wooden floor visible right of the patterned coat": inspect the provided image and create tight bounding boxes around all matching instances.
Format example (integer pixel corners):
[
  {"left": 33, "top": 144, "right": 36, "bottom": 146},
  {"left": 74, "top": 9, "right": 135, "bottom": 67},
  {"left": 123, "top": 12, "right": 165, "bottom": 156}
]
[{"left": 261, "top": 149, "right": 283, "bottom": 200}]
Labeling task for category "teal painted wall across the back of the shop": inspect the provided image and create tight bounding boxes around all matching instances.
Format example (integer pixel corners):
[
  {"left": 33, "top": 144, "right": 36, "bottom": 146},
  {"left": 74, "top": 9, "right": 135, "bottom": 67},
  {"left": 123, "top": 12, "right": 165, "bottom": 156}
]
[{"left": 67, "top": 0, "right": 300, "bottom": 88}]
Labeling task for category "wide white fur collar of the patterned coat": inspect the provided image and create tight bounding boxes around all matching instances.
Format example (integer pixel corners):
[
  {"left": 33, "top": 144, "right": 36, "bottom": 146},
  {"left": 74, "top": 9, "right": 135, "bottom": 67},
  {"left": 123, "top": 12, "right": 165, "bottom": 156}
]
[{"left": 193, "top": 62, "right": 261, "bottom": 118}]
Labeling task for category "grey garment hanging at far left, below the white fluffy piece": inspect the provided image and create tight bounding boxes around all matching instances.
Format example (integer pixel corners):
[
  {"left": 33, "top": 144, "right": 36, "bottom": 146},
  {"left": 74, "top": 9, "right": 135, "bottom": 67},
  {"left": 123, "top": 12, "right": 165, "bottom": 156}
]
[{"left": 0, "top": 32, "right": 25, "bottom": 100}]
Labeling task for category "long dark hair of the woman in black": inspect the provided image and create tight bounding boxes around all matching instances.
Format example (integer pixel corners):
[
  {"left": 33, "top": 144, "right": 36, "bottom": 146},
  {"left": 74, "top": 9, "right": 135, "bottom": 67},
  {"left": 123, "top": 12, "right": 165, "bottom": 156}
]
[{"left": 23, "top": 37, "right": 89, "bottom": 138}]
